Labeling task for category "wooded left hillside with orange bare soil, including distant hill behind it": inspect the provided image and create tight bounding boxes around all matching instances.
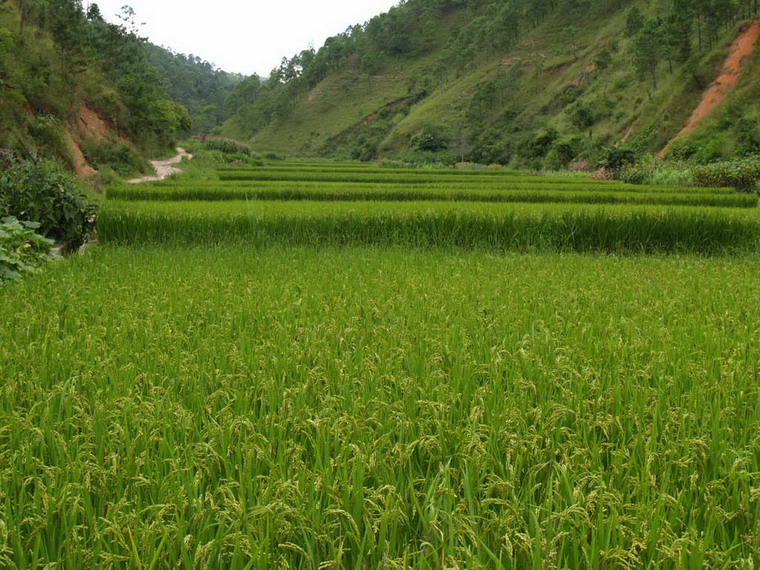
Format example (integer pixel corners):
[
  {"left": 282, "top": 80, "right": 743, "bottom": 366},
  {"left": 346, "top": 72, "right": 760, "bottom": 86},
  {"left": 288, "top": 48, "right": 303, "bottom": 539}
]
[{"left": 0, "top": 0, "right": 240, "bottom": 176}]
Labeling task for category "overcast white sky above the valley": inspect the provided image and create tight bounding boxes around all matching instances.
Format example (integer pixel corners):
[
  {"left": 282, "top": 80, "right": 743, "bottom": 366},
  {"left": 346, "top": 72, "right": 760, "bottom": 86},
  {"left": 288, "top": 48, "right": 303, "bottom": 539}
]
[{"left": 89, "top": 0, "right": 398, "bottom": 76}]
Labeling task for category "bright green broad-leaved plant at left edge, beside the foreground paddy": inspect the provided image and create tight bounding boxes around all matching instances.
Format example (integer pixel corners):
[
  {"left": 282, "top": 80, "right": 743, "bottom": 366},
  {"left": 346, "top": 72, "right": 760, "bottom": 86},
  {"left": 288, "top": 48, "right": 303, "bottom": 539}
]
[{"left": 0, "top": 216, "right": 55, "bottom": 285}]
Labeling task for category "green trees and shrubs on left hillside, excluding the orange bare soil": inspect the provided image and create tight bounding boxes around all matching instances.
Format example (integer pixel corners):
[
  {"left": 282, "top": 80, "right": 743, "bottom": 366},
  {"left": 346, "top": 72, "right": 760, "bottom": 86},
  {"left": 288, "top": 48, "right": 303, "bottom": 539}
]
[{"left": 0, "top": 0, "right": 191, "bottom": 165}]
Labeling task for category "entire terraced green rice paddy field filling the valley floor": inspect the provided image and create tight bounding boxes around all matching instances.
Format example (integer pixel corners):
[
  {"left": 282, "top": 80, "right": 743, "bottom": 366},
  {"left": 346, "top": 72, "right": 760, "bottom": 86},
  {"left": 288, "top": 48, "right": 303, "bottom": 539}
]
[{"left": 0, "top": 163, "right": 760, "bottom": 570}]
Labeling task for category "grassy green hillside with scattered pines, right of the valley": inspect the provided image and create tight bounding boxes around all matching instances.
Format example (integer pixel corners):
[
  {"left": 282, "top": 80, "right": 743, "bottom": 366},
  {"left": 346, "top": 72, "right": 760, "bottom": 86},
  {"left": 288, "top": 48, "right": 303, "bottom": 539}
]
[{"left": 222, "top": 0, "right": 760, "bottom": 167}]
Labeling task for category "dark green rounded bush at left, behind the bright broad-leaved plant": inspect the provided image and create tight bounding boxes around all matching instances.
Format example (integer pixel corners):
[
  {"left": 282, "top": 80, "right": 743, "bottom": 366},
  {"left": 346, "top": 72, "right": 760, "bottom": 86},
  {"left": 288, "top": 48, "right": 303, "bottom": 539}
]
[{"left": 0, "top": 162, "right": 95, "bottom": 251}]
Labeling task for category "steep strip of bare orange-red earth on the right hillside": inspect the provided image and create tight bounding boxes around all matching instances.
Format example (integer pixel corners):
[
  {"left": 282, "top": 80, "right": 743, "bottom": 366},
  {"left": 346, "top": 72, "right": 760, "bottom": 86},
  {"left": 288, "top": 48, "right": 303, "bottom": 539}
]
[{"left": 657, "top": 20, "right": 760, "bottom": 158}]
